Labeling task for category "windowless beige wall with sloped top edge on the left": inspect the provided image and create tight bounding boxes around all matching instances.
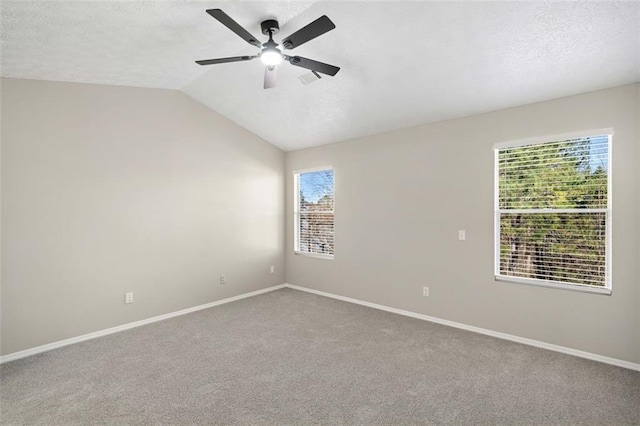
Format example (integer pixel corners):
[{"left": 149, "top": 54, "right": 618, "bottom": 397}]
[{"left": 1, "top": 79, "right": 285, "bottom": 354}]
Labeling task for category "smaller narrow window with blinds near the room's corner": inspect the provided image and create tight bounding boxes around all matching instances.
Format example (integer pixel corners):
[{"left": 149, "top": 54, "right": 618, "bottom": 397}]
[{"left": 293, "top": 168, "right": 334, "bottom": 258}]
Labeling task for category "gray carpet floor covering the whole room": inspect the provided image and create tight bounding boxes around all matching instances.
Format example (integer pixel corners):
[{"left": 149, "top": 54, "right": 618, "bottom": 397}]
[{"left": 0, "top": 289, "right": 640, "bottom": 425}]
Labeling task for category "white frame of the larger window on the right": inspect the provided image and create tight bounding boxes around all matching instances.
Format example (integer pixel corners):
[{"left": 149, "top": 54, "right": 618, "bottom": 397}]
[{"left": 493, "top": 128, "right": 614, "bottom": 295}]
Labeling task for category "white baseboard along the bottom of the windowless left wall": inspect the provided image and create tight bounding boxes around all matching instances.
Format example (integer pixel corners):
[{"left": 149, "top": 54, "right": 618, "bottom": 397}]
[{"left": 0, "top": 284, "right": 285, "bottom": 364}]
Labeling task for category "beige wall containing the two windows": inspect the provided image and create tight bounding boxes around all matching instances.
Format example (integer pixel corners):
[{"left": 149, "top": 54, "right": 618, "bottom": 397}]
[{"left": 286, "top": 84, "right": 640, "bottom": 363}]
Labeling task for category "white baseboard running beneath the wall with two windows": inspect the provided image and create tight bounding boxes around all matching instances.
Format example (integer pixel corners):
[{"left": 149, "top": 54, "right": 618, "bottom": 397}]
[{"left": 284, "top": 284, "right": 640, "bottom": 371}]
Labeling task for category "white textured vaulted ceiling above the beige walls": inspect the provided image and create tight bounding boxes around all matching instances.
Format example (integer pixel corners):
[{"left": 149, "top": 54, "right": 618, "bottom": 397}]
[{"left": 0, "top": 0, "right": 640, "bottom": 151}]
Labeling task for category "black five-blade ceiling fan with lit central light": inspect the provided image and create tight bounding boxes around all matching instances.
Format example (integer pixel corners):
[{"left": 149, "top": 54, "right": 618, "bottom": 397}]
[{"left": 196, "top": 9, "right": 340, "bottom": 89}]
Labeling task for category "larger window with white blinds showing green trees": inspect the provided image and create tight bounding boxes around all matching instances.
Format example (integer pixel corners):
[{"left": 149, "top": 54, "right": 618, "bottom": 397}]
[{"left": 495, "top": 130, "right": 611, "bottom": 294}]
